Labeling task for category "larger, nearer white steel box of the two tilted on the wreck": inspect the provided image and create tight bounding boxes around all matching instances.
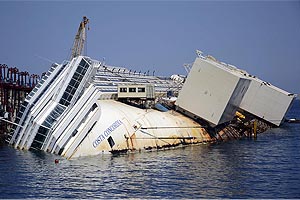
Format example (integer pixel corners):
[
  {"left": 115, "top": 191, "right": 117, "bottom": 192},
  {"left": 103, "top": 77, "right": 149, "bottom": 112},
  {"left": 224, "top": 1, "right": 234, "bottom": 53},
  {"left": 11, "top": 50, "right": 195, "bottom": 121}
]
[{"left": 176, "top": 58, "right": 250, "bottom": 125}]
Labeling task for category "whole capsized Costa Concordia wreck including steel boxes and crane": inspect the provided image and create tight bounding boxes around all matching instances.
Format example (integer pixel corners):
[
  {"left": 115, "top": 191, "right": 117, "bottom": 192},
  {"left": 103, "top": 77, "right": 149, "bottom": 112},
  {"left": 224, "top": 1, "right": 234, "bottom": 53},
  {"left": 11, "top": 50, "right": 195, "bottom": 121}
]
[{"left": 7, "top": 18, "right": 296, "bottom": 159}]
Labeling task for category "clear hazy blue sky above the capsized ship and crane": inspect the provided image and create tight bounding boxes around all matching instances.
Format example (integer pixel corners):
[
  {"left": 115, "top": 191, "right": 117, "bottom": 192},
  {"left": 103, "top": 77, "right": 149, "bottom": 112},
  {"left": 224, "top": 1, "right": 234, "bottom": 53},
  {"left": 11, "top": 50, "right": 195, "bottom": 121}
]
[{"left": 0, "top": 1, "right": 300, "bottom": 93}]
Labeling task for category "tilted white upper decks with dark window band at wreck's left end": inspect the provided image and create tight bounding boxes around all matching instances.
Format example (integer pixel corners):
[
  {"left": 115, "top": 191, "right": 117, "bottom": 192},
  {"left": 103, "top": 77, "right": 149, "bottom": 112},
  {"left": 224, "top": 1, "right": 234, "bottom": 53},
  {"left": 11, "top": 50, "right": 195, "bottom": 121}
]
[{"left": 6, "top": 57, "right": 97, "bottom": 150}]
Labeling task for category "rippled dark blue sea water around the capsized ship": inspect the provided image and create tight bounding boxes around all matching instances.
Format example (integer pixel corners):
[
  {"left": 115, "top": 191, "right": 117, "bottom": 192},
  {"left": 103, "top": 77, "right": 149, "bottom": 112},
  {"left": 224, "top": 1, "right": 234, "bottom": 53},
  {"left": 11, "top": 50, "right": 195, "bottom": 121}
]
[{"left": 0, "top": 100, "right": 300, "bottom": 199}]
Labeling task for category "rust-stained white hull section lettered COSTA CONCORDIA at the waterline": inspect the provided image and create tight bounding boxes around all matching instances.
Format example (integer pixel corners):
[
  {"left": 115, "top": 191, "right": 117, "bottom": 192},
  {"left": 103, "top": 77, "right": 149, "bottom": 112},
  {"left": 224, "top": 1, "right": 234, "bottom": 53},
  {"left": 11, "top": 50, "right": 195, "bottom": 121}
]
[{"left": 60, "top": 100, "right": 211, "bottom": 158}]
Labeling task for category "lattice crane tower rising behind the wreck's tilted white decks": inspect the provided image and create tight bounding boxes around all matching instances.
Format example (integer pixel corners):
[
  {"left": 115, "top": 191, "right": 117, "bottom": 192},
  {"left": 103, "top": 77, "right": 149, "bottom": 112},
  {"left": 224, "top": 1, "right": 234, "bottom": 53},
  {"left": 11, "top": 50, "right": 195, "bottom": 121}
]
[{"left": 70, "top": 16, "right": 89, "bottom": 60}]
